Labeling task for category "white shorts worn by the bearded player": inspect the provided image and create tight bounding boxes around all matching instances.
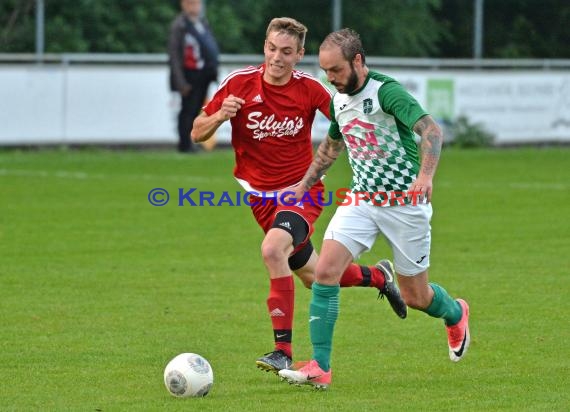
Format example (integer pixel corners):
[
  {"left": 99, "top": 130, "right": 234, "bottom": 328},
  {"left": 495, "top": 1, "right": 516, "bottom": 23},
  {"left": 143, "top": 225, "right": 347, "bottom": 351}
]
[{"left": 324, "top": 194, "right": 432, "bottom": 276}]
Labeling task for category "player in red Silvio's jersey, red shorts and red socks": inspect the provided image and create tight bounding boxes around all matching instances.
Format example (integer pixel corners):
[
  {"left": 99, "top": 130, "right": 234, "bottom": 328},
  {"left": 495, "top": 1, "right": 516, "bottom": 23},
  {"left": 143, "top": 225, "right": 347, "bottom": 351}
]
[{"left": 191, "top": 17, "right": 407, "bottom": 373}]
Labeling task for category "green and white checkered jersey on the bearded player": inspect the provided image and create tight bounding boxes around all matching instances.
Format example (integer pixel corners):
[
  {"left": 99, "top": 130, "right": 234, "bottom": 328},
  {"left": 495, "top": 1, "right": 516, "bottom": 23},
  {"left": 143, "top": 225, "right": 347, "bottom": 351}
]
[{"left": 329, "top": 71, "right": 427, "bottom": 206}]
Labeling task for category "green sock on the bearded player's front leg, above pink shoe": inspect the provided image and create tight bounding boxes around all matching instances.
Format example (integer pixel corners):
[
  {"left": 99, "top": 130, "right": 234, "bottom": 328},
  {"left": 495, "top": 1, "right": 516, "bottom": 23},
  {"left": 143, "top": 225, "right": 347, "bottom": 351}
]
[{"left": 309, "top": 282, "right": 340, "bottom": 372}]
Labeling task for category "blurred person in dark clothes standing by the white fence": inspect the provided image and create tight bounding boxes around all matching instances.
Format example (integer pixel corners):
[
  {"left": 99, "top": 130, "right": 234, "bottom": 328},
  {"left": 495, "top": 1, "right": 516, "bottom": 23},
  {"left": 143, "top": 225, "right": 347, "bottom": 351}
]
[{"left": 168, "top": 0, "right": 219, "bottom": 153}]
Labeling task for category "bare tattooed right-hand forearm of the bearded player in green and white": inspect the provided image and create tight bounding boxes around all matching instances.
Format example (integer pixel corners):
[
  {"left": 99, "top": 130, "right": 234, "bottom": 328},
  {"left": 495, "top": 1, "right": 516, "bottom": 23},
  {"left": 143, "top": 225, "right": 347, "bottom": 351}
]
[{"left": 408, "top": 115, "right": 443, "bottom": 202}]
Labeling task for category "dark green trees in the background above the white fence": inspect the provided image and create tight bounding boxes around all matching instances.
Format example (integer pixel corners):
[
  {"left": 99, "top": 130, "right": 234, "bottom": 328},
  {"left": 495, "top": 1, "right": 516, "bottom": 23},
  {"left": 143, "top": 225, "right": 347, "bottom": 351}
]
[{"left": 0, "top": 0, "right": 570, "bottom": 59}]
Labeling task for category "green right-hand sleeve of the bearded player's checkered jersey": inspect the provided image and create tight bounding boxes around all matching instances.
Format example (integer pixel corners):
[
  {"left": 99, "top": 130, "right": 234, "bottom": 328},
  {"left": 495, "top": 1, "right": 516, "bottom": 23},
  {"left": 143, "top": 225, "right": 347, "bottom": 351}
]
[{"left": 378, "top": 81, "right": 428, "bottom": 130}]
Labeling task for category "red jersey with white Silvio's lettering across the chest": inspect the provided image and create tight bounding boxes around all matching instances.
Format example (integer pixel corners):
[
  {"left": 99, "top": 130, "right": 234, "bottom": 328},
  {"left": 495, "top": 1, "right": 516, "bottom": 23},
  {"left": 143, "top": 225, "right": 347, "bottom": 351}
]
[{"left": 204, "top": 65, "right": 331, "bottom": 191}]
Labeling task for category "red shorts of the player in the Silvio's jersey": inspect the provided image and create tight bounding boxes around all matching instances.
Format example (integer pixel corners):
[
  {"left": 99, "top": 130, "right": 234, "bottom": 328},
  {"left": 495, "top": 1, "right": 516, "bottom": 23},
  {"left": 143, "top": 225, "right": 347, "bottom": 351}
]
[{"left": 249, "top": 182, "right": 325, "bottom": 253}]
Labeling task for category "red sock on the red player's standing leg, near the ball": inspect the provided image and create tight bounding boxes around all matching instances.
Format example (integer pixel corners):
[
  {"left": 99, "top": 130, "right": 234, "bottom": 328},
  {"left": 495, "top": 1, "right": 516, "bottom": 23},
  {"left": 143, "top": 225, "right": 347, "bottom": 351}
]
[{"left": 267, "top": 276, "right": 295, "bottom": 357}]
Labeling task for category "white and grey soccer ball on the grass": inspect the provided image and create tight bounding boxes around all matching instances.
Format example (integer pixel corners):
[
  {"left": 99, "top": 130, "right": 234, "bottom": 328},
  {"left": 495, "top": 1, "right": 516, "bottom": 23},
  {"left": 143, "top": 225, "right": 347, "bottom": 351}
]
[{"left": 164, "top": 353, "right": 214, "bottom": 398}]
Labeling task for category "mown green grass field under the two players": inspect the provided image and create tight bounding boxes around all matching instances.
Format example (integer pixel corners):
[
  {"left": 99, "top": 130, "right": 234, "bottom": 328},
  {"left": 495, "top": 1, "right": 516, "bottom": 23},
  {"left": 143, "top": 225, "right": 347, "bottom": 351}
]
[{"left": 0, "top": 148, "right": 570, "bottom": 411}]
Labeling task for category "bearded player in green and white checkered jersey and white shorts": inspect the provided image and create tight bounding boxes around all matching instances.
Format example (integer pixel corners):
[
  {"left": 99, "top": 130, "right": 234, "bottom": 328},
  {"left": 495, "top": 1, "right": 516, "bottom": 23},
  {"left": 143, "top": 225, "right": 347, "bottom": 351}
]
[{"left": 279, "top": 29, "right": 470, "bottom": 388}]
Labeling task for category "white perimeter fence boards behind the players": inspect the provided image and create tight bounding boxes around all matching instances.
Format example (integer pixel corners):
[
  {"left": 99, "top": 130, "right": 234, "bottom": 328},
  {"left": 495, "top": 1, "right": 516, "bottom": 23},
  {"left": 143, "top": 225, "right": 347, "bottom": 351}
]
[{"left": 0, "top": 55, "right": 570, "bottom": 146}]
